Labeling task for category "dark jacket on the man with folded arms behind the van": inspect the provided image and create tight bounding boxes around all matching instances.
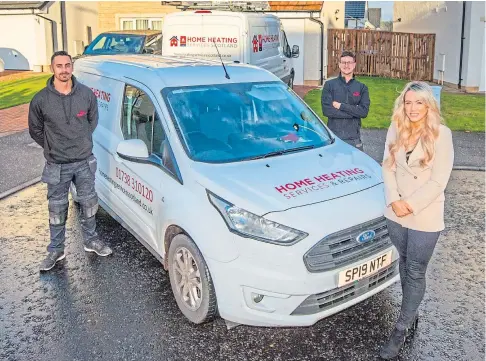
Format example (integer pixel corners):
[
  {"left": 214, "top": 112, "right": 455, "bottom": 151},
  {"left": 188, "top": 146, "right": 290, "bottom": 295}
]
[{"left": 321, "top": 74, "right": 370, "bottom": 140}]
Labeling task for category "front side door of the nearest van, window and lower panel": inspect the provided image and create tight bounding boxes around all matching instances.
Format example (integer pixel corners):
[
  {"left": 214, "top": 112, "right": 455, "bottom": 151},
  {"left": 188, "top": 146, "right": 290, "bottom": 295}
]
[{"left": 115, "top": 85, "right": 177, "bottom": 254}]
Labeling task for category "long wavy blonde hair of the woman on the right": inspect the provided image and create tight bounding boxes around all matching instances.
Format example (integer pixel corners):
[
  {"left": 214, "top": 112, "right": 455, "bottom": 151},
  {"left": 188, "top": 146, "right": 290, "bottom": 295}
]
[{"left": 384, "top": 81, "right": 443, "bottom": 167}]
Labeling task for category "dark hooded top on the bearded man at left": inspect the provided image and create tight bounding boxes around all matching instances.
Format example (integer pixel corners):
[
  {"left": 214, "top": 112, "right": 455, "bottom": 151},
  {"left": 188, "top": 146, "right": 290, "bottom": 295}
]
[{"left": 29, "top": 76, "right": 98, "bottom": 163}]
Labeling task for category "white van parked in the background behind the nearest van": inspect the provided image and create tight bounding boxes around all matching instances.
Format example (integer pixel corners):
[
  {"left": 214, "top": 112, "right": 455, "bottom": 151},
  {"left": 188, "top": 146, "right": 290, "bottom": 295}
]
[{"left": 162, "top": 10, "right": 299, "bottom": 88}]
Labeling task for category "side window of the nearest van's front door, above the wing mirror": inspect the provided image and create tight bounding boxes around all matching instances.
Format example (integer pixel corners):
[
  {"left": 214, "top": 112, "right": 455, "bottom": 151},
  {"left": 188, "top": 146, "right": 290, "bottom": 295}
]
[{"left": 121, "top": 85, "right": 176, "bottom": 174}]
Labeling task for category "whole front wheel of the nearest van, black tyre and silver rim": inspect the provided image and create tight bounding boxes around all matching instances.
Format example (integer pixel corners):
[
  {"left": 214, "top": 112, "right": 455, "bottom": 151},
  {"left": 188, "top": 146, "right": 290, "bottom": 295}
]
[{"left": 168, "top": 234, "right": 218, "bottom": 324}]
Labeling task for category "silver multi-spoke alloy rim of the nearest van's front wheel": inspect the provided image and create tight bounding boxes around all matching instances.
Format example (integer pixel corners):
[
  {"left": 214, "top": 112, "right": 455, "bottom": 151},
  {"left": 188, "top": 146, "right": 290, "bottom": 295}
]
[{"left": 172, "top": 247, "right": 203, "bottom": 311}]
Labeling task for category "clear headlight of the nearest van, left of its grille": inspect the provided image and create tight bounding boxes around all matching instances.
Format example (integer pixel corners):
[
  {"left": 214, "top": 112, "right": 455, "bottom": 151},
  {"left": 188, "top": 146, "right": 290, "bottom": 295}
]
[{"left": 207, "top": 191, "right": 308, "bottom": 246}]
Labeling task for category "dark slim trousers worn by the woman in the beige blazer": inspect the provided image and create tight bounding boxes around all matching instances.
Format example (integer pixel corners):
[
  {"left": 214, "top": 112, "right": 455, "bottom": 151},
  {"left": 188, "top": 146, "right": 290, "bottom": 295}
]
[{"left": 386, "top": 219, "right": 440, "bottom": 330}]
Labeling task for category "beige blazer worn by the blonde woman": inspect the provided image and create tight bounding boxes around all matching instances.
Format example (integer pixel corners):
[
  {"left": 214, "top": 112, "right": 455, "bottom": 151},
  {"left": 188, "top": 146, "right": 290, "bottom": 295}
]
[{"left": 382, "top": 122, "right": 454, "bottom": 232}]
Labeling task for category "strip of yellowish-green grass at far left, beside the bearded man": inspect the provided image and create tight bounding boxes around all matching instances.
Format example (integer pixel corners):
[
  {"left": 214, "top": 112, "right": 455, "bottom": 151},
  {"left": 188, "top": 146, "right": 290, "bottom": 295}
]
[{"left": 0, "top": 75, "right": 50, "bottom": 109}]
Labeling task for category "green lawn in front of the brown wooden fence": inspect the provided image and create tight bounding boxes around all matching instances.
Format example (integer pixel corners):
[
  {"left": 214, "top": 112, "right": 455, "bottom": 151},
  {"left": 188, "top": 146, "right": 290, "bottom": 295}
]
[{"left": 304, "top": 77, "right": 485, "bottom": 132}]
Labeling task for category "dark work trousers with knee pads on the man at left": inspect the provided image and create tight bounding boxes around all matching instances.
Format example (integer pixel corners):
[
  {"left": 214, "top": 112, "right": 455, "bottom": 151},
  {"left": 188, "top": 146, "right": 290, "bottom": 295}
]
[{"left": 42, "top": 156, "right": 98, "bottom": 252}]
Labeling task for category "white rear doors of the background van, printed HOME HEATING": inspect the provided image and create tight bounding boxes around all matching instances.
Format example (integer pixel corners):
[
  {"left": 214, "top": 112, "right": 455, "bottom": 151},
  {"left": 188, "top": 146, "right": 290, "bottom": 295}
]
[{"left": 162, "top": 10, "right": 243, "bottom": 62}]
